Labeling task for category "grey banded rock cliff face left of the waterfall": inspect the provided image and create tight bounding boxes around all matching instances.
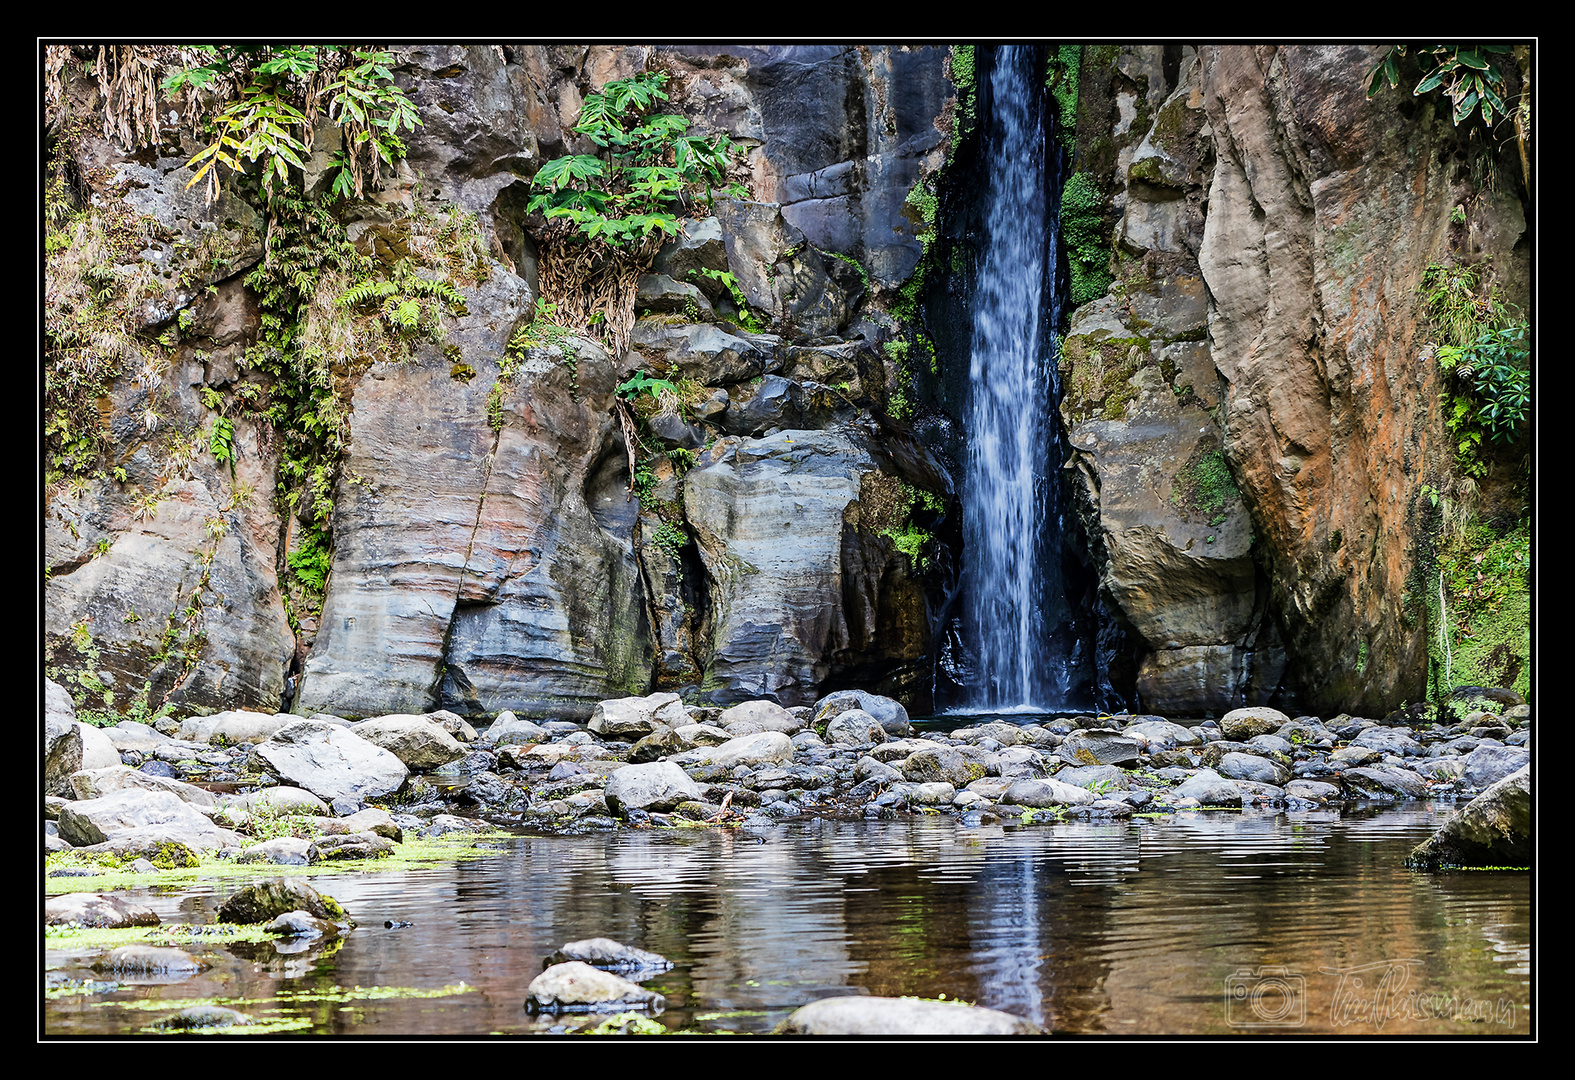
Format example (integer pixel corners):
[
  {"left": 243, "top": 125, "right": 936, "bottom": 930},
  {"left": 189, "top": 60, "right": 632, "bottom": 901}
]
[{"left": 46, "top": 46, "right": 951, "bottom": 719}]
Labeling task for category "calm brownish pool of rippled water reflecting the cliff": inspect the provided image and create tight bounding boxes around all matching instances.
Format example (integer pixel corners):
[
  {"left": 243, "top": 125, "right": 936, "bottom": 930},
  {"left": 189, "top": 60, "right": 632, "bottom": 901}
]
[{"left": 44, "top": 804, "right": 1534, "bottom": 1036}]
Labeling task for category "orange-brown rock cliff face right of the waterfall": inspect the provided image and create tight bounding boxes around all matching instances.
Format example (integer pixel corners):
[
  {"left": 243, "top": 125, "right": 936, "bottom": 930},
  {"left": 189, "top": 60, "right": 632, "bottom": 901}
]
[{"left": 1062, "top": 46, "right": 1529, "bottom": 712}]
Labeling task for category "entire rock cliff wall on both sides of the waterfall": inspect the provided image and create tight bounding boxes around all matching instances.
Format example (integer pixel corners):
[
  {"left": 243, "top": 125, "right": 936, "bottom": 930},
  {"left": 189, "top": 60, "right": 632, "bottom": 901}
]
[{"left": 44, "top": 44, "right": 1529, "bottom": 719}]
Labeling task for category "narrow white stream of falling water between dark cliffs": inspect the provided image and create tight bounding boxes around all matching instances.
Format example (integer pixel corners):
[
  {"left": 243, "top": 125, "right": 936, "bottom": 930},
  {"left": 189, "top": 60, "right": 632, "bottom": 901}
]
[{"left": 964, "top": 47, "right": 1069, "bottom": 712}]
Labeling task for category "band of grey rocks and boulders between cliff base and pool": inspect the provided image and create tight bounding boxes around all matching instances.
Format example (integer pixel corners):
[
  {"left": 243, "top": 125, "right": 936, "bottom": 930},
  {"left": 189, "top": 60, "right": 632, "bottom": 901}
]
[{"left": 44, "top": 685, "right": 1531, "bottom": 866}]
